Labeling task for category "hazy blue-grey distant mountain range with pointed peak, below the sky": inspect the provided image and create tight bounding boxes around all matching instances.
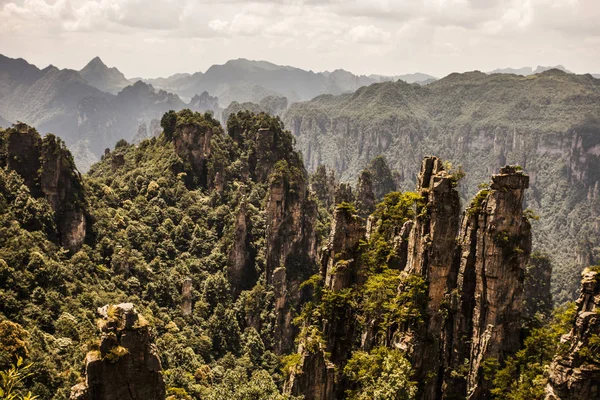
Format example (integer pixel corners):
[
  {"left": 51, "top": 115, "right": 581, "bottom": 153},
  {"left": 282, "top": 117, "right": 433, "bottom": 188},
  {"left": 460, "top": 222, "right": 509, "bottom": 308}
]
[{"left": 0, "top": 55, "right": 435, "bottom": 171}]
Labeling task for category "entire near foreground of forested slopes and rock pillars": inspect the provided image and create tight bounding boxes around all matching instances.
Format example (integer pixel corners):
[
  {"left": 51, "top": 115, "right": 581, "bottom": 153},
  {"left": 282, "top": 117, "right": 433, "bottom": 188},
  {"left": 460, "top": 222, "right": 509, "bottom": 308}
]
[{"left": 0, "top": 110, "right": 600, "bottom": 400}]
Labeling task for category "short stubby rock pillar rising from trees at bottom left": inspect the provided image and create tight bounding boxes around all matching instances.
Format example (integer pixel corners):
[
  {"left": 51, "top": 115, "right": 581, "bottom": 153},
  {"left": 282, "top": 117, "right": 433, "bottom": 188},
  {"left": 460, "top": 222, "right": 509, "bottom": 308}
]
[{"left": 71, "top": 303, "right": 166, "bottom": 400}]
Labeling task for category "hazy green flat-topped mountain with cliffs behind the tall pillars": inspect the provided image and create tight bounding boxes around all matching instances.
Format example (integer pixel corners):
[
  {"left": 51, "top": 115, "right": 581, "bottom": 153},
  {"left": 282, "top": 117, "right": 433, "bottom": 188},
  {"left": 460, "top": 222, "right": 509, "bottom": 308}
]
[{"left": 284, "top": 70, "right": 600, "bottom": 302}]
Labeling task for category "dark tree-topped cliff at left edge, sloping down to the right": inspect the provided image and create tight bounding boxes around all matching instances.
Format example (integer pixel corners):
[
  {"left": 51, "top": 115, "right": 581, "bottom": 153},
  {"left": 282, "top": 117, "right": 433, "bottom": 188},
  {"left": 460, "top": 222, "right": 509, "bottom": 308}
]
[{"left": 0, "top": 124, "right": 88, "bottom": 251}]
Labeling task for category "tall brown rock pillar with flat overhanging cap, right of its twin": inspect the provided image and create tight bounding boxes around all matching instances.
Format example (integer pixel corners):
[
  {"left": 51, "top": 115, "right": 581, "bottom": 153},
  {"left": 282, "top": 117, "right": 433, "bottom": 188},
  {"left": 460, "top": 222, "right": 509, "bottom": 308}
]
[{"left": 445, "top": 166, "right": 531, "bottom": 399}]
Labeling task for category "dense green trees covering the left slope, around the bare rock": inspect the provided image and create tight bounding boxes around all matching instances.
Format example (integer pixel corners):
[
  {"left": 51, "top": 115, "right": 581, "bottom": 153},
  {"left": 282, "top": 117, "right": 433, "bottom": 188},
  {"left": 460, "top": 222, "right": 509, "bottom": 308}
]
[{"left": 0, "top": 110, "right": 308, "bottom": 400}]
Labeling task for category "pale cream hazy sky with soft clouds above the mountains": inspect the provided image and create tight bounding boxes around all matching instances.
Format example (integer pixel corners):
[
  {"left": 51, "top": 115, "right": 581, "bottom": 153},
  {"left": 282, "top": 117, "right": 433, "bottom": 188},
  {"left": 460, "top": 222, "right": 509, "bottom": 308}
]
[{"left": 0, "top": 0, "right": 600, "bottom": 77}]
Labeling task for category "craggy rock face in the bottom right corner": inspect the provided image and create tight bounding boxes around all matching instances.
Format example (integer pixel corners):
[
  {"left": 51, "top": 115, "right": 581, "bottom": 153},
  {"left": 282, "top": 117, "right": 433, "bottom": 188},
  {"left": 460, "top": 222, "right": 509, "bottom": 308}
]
[{"left": 546, "top": 268, "right": 600, "bottom": 400}]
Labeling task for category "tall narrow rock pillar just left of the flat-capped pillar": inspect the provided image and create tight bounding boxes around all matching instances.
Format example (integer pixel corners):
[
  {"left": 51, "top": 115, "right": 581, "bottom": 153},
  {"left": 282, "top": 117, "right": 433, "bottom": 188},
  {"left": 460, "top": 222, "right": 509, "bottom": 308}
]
[{"left": 405, "top": 157, "right": 460, "bottom": 399}]
